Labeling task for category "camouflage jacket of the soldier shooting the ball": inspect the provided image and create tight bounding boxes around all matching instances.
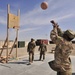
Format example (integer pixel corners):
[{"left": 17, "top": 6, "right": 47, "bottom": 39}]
[{"left": 50, "top": 29, "right": 73, "bottom": 70}]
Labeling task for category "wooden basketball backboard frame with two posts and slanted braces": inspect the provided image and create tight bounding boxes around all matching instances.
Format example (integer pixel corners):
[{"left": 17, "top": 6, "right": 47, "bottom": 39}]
[{"left": 0, "top": 5, "right": 20, "bottom": 63}]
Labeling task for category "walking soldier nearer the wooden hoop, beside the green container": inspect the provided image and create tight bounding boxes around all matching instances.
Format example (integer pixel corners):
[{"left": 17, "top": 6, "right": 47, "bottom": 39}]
[{"left": 27, "top": 38, "right": 36, "bottom": 64}]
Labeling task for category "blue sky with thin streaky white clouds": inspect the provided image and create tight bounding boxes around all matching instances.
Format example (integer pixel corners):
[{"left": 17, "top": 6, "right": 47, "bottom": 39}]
[{"left": 0, "top": 0, "right": 75, "bottom": 41}]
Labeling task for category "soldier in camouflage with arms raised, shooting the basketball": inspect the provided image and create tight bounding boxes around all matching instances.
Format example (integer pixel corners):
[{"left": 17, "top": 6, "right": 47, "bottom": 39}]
[{"left": 49, "top": 20, "right": 75, "bottom": 75}]
